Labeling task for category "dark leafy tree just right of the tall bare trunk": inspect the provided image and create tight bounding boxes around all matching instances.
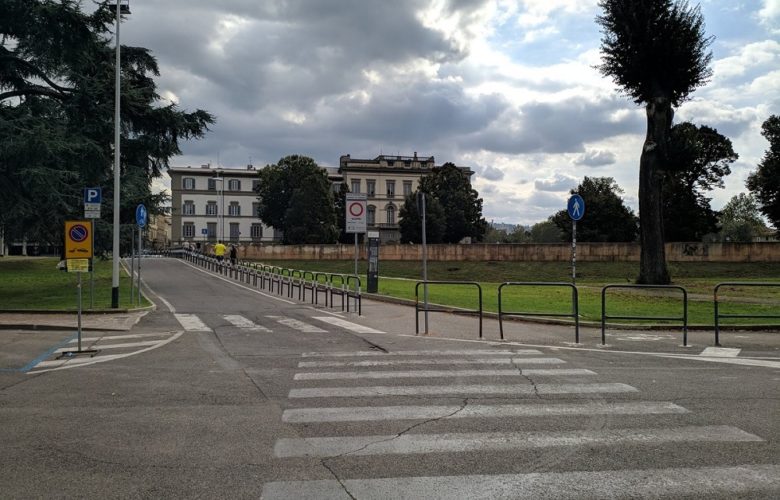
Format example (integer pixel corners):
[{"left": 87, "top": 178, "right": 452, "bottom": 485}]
[{"left": 663, "top": 122, "right": 739, "bottom": 241}]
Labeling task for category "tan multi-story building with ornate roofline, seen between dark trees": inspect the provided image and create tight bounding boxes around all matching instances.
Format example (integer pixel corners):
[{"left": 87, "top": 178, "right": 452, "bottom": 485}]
[{"left": 339, "top": 152, "right": 474, "bottom": 243}]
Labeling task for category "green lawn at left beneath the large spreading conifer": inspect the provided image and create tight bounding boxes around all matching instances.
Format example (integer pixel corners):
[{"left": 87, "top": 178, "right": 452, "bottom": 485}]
[{"left": 0, "top": 257, "right": 150, "bottom": 311}]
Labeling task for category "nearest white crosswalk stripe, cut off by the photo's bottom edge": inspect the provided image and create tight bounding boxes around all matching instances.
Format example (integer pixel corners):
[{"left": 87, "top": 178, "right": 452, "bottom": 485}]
[{"left": 260, "top": 465, "right": 780, "bottom": 500}]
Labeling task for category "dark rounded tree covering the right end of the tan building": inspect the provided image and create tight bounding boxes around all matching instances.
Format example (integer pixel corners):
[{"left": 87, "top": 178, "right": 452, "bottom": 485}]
[{"left": 419, "top": 162, "right": 487, "bottom": 243}]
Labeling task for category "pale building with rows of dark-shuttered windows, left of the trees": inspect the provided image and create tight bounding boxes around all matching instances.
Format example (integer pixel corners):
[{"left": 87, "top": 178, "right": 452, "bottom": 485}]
[{"left": 168, "top": 165, "right": 280, "bottom": 245}]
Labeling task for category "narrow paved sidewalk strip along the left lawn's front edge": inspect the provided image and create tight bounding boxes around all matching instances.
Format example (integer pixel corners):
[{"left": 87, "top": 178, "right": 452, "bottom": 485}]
[{"left": 0, "top": 310, "right": 149, "bottom": 331}]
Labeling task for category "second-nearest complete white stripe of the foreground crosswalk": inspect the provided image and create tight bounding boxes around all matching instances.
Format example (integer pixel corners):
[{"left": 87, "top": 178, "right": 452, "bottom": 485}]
[{"left": 274, "top": 425, "right": 763, "bottom": 458}]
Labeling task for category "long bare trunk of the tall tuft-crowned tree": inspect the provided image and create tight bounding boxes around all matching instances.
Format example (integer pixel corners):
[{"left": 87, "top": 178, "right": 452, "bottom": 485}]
[{"left": 637, "top": 97, "right": 673, "bottom": 285}]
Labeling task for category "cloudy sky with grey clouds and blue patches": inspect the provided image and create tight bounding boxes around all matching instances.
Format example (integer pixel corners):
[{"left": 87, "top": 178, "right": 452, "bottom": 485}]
[{"left": 121, "top": 0, "right": 780, "bottom": 224}]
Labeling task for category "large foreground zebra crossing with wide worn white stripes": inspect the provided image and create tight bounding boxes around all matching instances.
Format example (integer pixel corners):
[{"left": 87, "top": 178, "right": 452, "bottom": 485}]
[{"left": 262, "top": 348, "right": 780, "bottom": 500}]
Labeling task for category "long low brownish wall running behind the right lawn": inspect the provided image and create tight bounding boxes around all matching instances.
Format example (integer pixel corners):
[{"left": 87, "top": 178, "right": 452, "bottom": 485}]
[{"left": 230, "top": 242, "right": 780, "bottom": 262}]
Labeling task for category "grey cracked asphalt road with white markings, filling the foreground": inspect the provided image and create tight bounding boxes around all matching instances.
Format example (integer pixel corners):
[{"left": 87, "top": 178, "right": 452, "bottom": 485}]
[{"left": 0, "top": 259, "right": 780, "bottom": 499}]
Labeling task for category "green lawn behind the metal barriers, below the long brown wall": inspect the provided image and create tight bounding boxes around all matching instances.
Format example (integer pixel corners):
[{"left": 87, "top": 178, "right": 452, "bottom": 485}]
[{"left": 247, "top": 261, "right": 780, "bottom": 325}]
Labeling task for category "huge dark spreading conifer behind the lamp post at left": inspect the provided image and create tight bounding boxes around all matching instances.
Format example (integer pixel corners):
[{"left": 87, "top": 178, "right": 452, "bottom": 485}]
[{"left": 0, "top": 0, "right": 213, "bottom": 251}]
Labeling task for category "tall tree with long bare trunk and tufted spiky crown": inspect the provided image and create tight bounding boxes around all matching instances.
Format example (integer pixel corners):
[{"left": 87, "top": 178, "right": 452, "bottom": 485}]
[{"left": 596, "top": 0, "right": 712, "bottom": 284}]
